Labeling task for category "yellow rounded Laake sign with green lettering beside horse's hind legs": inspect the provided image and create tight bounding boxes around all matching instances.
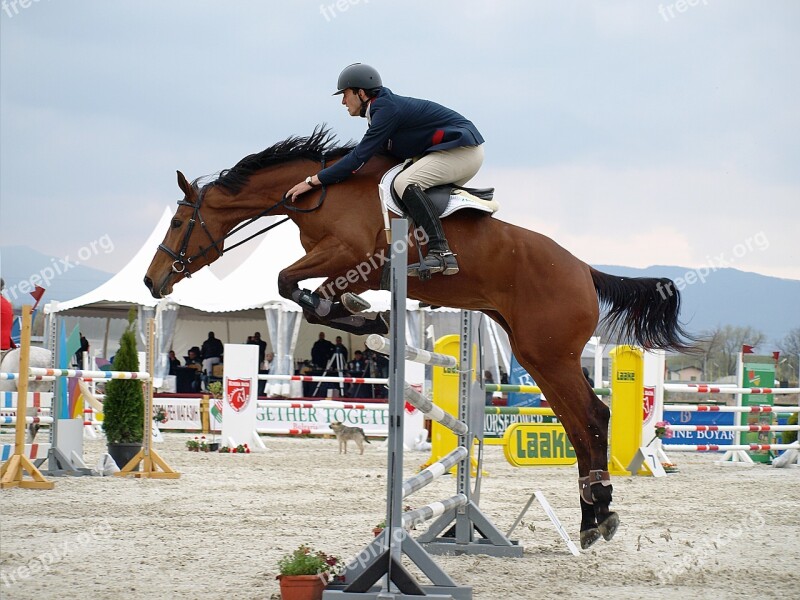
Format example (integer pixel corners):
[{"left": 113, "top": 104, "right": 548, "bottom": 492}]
[{"left": 503, "top": 423, "right": 578, "bottom": 467}]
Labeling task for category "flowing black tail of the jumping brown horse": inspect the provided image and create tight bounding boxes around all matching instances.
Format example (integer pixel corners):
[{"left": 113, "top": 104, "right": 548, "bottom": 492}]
[{"left": 591, "top": 269, "right": 696, "bottom": 352}]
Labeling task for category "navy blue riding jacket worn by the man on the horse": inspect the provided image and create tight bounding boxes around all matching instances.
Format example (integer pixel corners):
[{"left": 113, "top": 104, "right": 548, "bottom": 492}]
[{"left": 317, "top": 87, "right": 484, "bottom": 185}]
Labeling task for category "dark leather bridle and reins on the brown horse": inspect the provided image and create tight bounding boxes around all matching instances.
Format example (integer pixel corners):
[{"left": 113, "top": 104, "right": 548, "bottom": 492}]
[{"left": 158, "top": 156, "right": 328, "bottom": 278}]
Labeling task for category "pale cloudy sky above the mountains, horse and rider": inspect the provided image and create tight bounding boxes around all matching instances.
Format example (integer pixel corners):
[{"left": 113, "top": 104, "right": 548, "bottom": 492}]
[{"left": 0, "top": 0, "right": 800, "bottom": 279}]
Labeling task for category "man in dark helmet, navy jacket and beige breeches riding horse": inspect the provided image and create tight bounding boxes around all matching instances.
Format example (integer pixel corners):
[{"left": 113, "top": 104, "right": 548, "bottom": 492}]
[{"left": 287, "top": 63, "right": 484, "bottom": 275}]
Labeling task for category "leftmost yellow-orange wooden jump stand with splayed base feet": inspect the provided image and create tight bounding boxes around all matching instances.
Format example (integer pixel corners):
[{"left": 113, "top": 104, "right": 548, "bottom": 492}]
[{"left": 0, "top": 304, "right": 55, "bottom": 490}]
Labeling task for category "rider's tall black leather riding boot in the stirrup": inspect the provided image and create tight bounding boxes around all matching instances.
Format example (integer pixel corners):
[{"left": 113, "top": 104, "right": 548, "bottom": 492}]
[{"left": 402, "top": 183, "right": 458, "bottom": 277}]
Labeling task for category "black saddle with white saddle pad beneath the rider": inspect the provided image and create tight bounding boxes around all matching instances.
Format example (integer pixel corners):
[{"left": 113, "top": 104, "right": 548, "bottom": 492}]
[{"left": 378, "top": 164, "right": 500, "bottom": 220}]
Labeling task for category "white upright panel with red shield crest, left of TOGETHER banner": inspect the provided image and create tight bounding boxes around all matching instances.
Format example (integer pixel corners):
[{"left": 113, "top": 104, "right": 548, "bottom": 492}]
[{"left": 222, "top": 344, "right": 258, "bottom": 447}]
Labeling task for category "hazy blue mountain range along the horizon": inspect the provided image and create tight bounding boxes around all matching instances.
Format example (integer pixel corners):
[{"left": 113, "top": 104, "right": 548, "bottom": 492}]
[{"left": 0, "top": 246, "right": 800, "bottom": 351}]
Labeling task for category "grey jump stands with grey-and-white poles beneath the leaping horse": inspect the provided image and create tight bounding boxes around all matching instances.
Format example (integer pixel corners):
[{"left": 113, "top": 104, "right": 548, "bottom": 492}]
[{"left": 322, "top": 219, "right": 522, "bottom": 600}]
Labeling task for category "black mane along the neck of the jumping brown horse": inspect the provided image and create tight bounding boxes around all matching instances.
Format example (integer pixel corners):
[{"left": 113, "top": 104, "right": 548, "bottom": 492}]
[{"left": 213, "top": 125, "right": 354, "bottom": 194}]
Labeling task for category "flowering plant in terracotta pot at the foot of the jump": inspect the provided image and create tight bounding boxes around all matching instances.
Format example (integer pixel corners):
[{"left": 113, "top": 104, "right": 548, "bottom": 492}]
[{"left": 277, "top": 544, "right": 343, "bottom": 600}]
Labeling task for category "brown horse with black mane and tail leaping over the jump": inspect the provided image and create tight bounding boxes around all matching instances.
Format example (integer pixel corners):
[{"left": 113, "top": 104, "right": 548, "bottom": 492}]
[{"left": 144, "top": 126, "right": 693, "bottom": 548}]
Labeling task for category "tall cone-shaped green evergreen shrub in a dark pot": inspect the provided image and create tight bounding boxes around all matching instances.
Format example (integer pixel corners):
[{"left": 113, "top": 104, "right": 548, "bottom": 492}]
[{"left": 103, "top": 310, "right": 144, "bottom": 470}]
